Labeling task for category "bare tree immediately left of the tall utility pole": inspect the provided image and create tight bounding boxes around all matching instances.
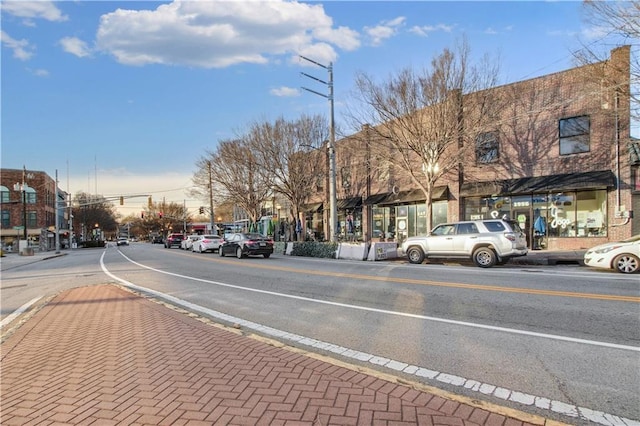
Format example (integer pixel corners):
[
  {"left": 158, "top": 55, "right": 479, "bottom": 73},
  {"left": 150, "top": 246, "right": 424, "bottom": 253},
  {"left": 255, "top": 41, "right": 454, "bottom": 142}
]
[{"left": 248, "top": 115, "right": 329, "bottom": 225}]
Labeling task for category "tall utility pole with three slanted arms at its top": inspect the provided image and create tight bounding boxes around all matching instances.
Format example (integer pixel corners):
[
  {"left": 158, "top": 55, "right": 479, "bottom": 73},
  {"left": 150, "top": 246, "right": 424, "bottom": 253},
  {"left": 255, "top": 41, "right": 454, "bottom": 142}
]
[{"left": 300, "top": 55, "right": 338, "bottom": 242}]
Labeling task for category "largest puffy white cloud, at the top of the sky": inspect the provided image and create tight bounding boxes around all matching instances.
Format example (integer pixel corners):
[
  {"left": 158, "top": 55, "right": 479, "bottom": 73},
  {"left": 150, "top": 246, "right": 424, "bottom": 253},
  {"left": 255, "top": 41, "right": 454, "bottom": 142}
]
[{"left": 96, "top": 0, "right": 360, "bottom": 68}]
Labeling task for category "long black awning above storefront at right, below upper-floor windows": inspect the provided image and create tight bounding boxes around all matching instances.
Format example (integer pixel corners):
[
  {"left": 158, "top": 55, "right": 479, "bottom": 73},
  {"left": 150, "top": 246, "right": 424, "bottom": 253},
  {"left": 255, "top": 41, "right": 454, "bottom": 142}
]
[{"left": 460, "top": 170, "right": 616, "bottom": 197}]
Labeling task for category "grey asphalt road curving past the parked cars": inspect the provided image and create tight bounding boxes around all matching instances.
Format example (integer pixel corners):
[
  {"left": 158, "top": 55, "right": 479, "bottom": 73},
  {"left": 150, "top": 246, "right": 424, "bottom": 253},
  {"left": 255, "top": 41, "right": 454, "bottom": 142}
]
[{"left": 2, "top": 243, "right": 640, "bottom": 424}]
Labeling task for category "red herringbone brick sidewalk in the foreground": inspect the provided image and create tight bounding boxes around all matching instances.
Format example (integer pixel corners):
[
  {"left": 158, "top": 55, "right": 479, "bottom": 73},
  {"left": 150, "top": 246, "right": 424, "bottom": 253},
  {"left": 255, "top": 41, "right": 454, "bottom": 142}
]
[{"left": 0, "top": 285, "right": 551, "bottom": 426}]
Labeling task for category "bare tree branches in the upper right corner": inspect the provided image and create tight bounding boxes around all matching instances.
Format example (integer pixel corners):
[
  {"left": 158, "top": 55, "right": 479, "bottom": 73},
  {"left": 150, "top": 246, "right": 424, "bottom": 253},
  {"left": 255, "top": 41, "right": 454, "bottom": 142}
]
[{"left": 575, "top": 0, "right": 640, "bottom": 123}]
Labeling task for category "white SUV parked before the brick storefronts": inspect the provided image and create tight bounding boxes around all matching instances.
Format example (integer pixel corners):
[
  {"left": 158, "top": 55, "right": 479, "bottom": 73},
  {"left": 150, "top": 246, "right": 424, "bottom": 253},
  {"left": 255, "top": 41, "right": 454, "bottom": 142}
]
[{"left": 402, "top": 219, "right": 527, "bottom": 268}]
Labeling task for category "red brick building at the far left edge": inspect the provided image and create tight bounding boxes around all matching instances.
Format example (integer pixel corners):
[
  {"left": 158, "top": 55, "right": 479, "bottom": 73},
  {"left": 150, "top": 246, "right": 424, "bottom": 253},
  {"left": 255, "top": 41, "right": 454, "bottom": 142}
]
[{"left": 0, "top": 169, "right": 69, "bottom": 251}]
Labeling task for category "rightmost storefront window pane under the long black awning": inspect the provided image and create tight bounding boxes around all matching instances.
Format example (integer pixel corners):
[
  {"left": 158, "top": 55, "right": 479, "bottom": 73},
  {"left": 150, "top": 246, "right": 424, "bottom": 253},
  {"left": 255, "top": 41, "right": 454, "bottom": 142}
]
[{"left": 576, "top": 190, "right": 607, "bottom": 237}]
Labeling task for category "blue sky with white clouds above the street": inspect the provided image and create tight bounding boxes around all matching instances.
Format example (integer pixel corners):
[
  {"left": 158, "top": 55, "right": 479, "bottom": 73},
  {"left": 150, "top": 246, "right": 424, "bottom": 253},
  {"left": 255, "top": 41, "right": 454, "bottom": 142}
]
[{"left": 0, "top": 0, "right": 638, "bottom": 215}]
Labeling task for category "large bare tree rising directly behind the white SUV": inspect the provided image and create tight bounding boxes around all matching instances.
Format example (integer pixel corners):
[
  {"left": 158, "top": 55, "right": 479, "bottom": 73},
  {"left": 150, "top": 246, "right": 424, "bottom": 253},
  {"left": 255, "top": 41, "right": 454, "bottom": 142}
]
[{"left": 350, "top": 41, "right": 499, "bottom": 229}]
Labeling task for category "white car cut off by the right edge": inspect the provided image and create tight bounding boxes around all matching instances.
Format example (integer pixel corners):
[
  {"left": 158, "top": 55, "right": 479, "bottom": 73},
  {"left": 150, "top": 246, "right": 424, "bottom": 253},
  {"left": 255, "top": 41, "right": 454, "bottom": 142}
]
[{"left": 584, "top": 234, "right": 640, "bottom": 274}]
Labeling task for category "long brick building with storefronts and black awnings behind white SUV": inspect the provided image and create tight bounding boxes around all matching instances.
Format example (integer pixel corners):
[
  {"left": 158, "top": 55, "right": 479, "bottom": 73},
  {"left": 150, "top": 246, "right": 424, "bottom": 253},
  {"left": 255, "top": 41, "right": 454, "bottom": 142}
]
[{"left": 304, "top": 46, "right": 640, "bottom": 249}]
